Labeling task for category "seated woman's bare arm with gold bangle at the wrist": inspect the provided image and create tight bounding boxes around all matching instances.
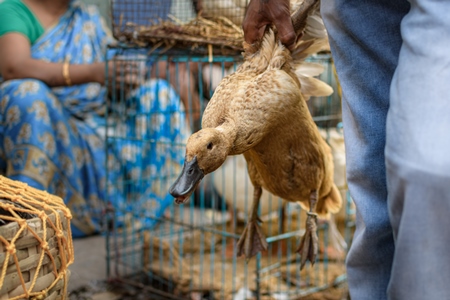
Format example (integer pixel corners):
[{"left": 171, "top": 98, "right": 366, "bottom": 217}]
[{"left": 0, "top": 33, "right": 105, "bottom": 87}]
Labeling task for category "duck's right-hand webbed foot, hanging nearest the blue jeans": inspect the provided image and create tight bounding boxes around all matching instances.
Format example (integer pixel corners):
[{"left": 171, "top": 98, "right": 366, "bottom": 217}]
[{"left": 297, "top": 191, "right": 319, "bottom": 270}]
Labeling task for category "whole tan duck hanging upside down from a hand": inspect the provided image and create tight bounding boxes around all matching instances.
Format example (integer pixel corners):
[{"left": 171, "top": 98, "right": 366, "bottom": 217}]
[{"left": 170, "top": 0, "right": 342, "bottom": 268}]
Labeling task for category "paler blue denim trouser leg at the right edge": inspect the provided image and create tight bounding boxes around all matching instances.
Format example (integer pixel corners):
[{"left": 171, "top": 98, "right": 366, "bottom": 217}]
[{"left": 386, "top": 0, "right": 450, "bottom": 300}]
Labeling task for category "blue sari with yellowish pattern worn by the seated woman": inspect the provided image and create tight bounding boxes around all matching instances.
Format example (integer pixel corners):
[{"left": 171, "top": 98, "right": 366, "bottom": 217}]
[{"left": 0, "top": 1, "right": 188, "bottom": 237}]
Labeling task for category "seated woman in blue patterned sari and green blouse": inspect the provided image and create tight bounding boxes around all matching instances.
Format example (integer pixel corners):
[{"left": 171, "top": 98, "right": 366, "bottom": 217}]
[{"left": 0, "top": 0, "right": 192, "bottom": 237}]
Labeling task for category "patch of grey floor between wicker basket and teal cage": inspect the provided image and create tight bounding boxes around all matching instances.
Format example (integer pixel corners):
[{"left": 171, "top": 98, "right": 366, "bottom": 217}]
[{"left": 69, "top": 236, "right": 106, "bottom": 291}]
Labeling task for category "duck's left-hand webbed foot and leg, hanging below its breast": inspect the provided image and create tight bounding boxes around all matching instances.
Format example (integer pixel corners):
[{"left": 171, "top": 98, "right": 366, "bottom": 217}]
[{"left": 237, "top": 187, "right": 268, "bottom": 260}]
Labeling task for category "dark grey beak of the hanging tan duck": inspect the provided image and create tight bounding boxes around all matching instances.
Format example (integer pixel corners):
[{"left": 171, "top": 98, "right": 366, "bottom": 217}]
[{"left": 169, "top": 157, "right": 205, "bottom": 204}]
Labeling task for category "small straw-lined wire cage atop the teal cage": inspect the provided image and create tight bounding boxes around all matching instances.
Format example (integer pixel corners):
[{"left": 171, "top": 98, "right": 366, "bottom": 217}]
[{"left": 111, "top": 0, "right": 249, "bottom": 52}]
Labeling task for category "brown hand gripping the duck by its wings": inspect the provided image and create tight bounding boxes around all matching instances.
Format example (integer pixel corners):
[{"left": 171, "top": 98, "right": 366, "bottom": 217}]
[{"left": 242, "top": 0, "right": 296, "bottom": 49}]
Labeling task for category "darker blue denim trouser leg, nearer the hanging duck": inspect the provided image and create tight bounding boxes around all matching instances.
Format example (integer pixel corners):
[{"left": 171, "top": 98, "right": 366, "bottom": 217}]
[{"left": 321, "top": 0, "right": 409, "bottom": 300}]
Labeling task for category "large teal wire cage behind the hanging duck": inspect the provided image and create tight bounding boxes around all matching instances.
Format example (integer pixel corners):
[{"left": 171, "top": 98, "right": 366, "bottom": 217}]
[{"left": 106, "top": 48, "right": 354, "bottom": 299}]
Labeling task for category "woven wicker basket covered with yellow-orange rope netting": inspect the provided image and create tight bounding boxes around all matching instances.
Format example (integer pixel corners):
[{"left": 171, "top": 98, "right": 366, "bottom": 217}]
[{"left": 0, "top": 176, "right": 73, "bottom": 300}]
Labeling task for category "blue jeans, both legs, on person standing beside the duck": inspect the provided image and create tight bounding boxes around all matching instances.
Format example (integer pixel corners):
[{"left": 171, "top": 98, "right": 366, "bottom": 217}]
[{"left": 321, "top": 0, "right": 450, "bottom": 300}]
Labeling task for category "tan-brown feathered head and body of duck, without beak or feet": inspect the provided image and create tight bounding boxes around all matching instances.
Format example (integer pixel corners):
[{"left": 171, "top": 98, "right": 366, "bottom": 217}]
[{"left": 179, "top": 0, "right": 342, "bottom": 215}]
